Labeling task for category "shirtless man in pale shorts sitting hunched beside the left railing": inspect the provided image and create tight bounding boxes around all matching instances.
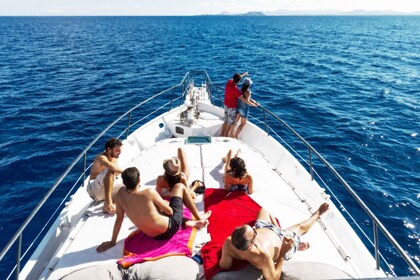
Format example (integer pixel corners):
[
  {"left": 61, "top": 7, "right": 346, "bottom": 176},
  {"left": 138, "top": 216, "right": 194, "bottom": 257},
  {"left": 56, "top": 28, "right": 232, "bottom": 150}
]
[{"left": 86, "top": 138, "right": 123, "bottom": 214}]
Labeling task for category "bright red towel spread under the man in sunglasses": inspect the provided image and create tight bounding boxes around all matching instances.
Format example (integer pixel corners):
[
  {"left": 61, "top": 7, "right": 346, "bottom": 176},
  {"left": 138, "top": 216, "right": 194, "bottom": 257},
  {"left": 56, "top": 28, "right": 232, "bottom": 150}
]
[{"left": 201, "top": 189, "right": 261, "bottom": 279}]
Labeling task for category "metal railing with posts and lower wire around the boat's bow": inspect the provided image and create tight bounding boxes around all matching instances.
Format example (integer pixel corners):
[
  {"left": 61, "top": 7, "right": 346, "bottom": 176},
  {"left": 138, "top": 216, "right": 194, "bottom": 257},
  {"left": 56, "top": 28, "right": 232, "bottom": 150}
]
[{"left": 0, "top": 70, "right": 420, "bottom": 279}]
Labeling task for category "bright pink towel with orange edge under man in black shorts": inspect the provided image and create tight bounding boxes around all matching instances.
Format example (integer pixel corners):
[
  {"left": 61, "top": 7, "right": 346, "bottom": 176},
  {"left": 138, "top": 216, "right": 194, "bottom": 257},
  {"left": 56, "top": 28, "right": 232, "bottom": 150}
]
[{"left": 117, "top": 206, "right": 196, "bottom": 268}]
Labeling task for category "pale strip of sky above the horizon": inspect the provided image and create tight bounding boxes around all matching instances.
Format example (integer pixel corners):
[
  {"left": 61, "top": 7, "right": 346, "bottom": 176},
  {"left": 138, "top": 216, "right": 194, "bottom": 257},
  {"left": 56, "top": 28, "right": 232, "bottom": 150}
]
[{"left": 0, "top": 0, "right": 420, "bottom": 16}]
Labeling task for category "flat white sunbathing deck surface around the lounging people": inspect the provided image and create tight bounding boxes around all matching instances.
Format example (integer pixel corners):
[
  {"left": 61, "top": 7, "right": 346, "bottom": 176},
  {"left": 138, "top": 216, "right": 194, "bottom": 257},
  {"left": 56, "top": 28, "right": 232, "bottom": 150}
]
[{"left": 42, "top": 138, "right": 378, "bottom": 279}]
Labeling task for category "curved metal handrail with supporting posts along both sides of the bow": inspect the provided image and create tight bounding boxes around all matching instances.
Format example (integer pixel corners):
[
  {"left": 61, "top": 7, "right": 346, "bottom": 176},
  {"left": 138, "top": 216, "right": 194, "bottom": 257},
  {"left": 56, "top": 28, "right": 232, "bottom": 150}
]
[{"left": 0, "top": 70, "right": 420, "bottom": 278}]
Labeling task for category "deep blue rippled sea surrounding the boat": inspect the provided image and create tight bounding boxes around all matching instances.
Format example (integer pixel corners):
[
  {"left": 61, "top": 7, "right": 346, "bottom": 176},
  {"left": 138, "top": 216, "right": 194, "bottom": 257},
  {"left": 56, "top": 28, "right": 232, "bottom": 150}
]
[{"left": 0, "top": 16, "right": 420, "bottom": 279}]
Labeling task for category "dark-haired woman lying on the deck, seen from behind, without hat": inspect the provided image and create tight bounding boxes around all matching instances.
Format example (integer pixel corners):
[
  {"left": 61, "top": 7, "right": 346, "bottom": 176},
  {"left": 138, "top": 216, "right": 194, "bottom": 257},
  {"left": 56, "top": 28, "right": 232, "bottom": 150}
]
[{"left": 223, "top": 150, "right": 254, "bottom": 194}]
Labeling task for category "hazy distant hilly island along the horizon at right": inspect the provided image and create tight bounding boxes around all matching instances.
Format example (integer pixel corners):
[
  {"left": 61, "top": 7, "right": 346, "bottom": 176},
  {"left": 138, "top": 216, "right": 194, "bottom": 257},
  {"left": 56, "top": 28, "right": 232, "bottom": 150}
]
[{"left": 202, "top": 9, "right": 420, "bottom": 16}]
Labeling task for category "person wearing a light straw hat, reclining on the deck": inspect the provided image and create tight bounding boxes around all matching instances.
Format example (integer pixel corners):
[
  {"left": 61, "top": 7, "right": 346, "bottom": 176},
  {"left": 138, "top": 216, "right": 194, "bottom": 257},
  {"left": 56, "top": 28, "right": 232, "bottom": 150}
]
[{"left": 156, "top": 147, "right": 203, "bottom": 198}]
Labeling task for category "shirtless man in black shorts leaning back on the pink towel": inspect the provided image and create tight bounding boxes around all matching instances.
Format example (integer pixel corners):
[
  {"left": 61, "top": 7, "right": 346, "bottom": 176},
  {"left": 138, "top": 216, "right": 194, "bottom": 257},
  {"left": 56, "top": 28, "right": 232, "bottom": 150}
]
[{"left": 96, "top": 167, "right": 211, "bottom": 252}]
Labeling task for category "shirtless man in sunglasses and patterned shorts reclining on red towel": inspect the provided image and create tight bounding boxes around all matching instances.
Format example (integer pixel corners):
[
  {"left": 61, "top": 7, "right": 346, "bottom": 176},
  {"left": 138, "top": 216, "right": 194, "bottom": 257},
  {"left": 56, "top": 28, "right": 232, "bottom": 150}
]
[{"left": 219, "top": 203, "right": 329, "bottom": 280}]
